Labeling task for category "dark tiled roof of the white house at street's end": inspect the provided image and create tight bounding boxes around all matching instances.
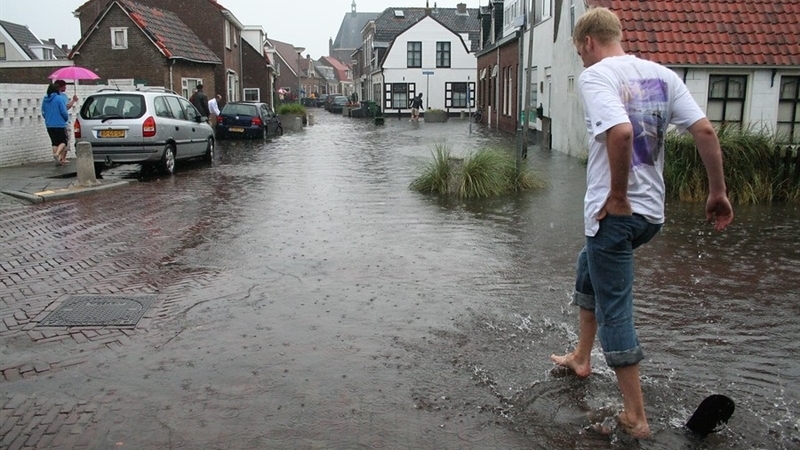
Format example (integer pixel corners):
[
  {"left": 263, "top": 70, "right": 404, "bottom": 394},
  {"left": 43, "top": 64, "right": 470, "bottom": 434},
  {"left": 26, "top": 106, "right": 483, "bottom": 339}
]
[{"left": 375, "top": 8, "right": 481, "bottom": 52}]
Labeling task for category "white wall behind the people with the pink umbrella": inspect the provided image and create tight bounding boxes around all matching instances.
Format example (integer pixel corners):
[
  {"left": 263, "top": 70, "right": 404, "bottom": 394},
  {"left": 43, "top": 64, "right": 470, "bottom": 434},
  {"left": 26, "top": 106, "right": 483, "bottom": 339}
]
[{"left": 0, "top": 83, "right": 131, "bottom": 167}]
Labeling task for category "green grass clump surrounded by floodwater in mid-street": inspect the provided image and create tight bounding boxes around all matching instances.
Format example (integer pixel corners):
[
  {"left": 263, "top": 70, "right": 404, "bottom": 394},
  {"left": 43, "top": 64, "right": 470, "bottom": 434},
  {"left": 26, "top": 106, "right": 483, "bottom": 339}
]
[{"left": 411, "top": 143, "right": 544, "bottom": 199}]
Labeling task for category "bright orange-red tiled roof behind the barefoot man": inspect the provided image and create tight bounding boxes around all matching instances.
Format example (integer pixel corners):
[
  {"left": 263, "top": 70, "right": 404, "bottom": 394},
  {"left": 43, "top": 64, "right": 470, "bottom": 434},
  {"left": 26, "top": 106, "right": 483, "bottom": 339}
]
[{"left": 588, "top": 0, "right": 800, "bottom": 66}]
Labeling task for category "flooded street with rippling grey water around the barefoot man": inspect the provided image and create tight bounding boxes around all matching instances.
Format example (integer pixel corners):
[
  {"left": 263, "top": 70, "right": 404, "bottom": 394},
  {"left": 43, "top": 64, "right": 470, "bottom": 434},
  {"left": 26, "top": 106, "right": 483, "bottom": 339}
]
[{"left": 0, "top": 109, "right": 800, "bottom": 450}]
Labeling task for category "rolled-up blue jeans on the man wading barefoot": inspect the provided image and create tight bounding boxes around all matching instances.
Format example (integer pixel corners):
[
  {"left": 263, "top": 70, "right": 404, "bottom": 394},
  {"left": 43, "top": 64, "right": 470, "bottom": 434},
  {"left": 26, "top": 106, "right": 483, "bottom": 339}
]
[{"left": 572, "top": 214, "right": 662, "bottom": 367}]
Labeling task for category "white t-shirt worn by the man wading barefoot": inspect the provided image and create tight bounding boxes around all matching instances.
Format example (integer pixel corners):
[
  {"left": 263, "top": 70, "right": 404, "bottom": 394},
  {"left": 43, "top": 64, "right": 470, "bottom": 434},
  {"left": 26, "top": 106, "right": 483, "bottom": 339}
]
[{"left": 578, "top": 55, "right": 705, "bottom": 236}]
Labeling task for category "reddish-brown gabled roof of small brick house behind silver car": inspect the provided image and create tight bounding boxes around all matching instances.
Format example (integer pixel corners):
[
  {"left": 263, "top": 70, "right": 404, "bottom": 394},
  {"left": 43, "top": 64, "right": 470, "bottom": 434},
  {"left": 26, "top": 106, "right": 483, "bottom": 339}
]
[{"left": 72, "top": 0, "right": 222, "bottom": 64}]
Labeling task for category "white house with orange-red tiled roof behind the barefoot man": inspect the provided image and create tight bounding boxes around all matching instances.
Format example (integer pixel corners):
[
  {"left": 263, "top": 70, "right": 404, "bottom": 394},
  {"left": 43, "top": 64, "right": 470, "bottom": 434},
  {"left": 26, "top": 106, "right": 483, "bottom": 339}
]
[{"left": 525, "top": 0, "right": 800, "bottom": 155}]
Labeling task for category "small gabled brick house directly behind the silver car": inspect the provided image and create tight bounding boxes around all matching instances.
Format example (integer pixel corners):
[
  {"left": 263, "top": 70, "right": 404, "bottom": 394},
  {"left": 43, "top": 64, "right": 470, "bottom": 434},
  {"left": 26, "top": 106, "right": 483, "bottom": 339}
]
[{"left": 70, "top": 0, "right": 220, "bottom": 97}]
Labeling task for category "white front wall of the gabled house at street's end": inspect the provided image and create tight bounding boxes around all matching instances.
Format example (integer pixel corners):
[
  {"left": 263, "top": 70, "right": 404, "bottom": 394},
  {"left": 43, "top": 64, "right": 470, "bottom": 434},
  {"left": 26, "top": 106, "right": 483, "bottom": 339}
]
[{"left": 383, "top": 17, "right": 477, "bottom": 112}]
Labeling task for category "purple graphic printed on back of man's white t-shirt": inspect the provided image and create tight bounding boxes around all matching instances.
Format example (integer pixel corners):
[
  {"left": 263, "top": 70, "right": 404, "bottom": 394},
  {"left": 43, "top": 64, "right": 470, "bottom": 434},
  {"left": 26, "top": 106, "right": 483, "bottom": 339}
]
[{"left": 622, "top": 78, "right": 669, "bottom": 167}]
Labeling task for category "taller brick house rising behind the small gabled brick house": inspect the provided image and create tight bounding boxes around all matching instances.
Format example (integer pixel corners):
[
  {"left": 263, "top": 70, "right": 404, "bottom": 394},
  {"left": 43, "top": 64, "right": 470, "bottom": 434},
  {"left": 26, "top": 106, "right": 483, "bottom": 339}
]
[{"left": 73, "top": 0, "right": 244, "bottom": 101}]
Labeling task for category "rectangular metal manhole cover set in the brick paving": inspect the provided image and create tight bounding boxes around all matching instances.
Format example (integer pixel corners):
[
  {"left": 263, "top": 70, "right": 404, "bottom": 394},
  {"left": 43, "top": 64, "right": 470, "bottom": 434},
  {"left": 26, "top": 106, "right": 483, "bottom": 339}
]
[{"left": 37, "top": 295, "right": 156, "bottom": 327}]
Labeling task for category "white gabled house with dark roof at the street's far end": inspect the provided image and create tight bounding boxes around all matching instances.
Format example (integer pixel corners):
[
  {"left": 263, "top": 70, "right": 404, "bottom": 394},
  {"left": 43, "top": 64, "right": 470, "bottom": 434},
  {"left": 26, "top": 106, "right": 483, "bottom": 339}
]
[{"left": 362, "top": 3, "right": 480, "bottom": 113}]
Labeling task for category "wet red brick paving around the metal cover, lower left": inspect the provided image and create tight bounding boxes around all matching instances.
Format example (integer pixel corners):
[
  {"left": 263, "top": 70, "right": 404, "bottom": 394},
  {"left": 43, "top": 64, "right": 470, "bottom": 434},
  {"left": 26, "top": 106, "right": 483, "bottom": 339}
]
[{"left": 0, "top": 169, "right": 219, "bottom": 450}]
